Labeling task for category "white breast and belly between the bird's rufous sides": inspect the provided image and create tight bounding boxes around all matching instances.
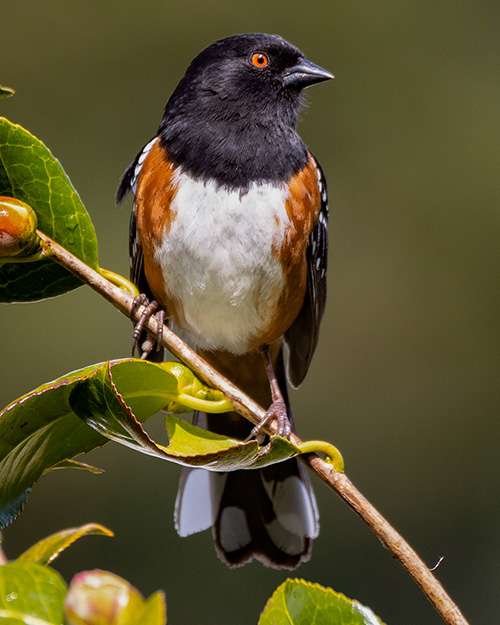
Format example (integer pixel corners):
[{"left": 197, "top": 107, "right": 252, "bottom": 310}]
[{"left": 156, "top": 173, "right": 290, "bottom": 354}]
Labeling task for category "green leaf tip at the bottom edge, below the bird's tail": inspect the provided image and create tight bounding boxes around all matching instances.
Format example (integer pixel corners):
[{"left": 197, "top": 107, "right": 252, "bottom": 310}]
[{"left": 259, "top": 579, "right": 383, "bottom": 625}]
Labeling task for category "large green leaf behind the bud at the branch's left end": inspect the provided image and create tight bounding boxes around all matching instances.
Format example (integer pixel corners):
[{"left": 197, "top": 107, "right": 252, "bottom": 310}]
[{"left": 0, "top": 118, "right": 98, "bottom": 302}]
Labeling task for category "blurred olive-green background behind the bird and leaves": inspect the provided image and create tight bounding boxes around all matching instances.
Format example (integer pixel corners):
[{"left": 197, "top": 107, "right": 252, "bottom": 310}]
[{"left": 0, "top": 0, "right": 500, "bottom": 625}]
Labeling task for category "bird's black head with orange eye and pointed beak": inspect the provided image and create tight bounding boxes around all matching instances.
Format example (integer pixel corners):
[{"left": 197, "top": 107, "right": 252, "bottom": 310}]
[{"left": 159, "top": 34, "right": 333, "bottom": 185}]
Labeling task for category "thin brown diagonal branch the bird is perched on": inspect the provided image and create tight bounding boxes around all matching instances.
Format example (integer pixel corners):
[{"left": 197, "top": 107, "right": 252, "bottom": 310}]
[{"left": 37, "top": 231, "right": 468, "bottom": 625}]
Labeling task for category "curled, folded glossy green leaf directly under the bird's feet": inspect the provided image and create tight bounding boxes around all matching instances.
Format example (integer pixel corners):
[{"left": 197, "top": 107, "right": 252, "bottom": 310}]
[{"left": 70, "top": 360, "right": 300, "bottom": 471}]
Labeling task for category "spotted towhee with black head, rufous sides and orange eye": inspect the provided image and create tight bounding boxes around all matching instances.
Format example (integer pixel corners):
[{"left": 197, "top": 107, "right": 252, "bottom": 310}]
[{"left": 117, "top": 34, "right": 333, "bottom": 568}]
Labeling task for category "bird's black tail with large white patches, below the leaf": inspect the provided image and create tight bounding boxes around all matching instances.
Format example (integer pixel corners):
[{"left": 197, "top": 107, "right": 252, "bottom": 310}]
[{"left": 175, "top": 348, "right": 319, "bottom": 569}]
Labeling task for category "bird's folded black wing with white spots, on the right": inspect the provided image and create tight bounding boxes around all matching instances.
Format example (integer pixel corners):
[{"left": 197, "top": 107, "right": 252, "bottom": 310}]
[{"left": 285, "top": 157, "right": 328, "bottom": 388}]
